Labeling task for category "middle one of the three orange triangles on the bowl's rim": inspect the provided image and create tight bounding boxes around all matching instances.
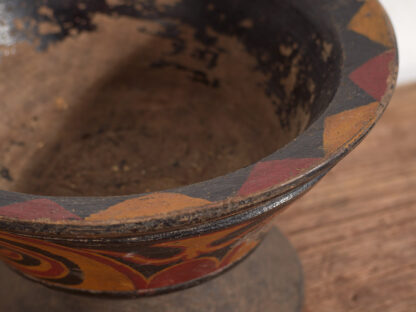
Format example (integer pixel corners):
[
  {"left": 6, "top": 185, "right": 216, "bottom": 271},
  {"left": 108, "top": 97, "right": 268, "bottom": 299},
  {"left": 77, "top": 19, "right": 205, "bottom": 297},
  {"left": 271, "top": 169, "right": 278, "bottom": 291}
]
[{"left": 324, "top": 102, "right": 379, "bottom": 154}]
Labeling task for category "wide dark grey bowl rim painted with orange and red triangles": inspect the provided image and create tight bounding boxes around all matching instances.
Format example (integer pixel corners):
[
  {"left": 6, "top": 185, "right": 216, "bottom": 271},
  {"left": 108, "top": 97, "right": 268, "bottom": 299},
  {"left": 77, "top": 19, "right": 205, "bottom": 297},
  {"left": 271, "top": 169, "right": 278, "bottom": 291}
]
[{"left": 0, "top": 0, "right": 398, "bottom": 237}]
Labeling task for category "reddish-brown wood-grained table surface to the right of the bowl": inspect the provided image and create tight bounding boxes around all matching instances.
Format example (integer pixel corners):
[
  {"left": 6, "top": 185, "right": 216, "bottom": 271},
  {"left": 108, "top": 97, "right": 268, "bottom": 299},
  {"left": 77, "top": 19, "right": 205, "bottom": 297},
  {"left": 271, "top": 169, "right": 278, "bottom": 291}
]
[{"left": 276, "top": 85, "right": 416, "bottom": 312}]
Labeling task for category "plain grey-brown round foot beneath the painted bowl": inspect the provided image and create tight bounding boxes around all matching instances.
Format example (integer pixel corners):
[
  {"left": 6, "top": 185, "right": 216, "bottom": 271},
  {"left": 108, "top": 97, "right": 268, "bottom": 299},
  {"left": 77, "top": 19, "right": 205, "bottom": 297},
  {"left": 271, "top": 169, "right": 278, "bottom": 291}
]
[{"left": 0, "top": 227, "right": 303, "bottom": 312}]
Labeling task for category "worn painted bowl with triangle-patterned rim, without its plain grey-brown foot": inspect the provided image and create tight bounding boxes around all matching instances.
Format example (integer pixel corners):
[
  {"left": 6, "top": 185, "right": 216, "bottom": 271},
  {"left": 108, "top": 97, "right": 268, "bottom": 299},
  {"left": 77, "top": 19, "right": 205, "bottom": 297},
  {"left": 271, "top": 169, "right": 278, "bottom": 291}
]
[{"left": 0, "top": 0, "right": 397, "bottom": 296}]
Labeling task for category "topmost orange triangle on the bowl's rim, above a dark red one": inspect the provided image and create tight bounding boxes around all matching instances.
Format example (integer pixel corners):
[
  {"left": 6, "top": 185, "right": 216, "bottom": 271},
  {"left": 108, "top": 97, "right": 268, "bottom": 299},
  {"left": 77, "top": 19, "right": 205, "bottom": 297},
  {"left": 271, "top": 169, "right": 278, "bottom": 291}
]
[{"left": 348, "top": 0, "right": 393, "bottom": 48}]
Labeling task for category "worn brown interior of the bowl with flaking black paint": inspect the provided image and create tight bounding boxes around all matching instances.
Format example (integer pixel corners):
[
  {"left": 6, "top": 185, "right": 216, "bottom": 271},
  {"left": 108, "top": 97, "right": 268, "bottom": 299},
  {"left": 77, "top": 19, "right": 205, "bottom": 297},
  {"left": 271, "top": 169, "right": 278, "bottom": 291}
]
[{"left": 0, "top": 0, "right": 341, "bottom": 196}]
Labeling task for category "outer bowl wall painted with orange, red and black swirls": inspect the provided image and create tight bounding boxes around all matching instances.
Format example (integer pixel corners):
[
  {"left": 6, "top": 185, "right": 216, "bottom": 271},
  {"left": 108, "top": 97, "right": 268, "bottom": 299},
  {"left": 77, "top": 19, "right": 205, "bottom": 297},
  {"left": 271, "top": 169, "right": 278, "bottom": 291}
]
[{"left": 0, "top": 205, "right": 280, "bottom": 296}]
